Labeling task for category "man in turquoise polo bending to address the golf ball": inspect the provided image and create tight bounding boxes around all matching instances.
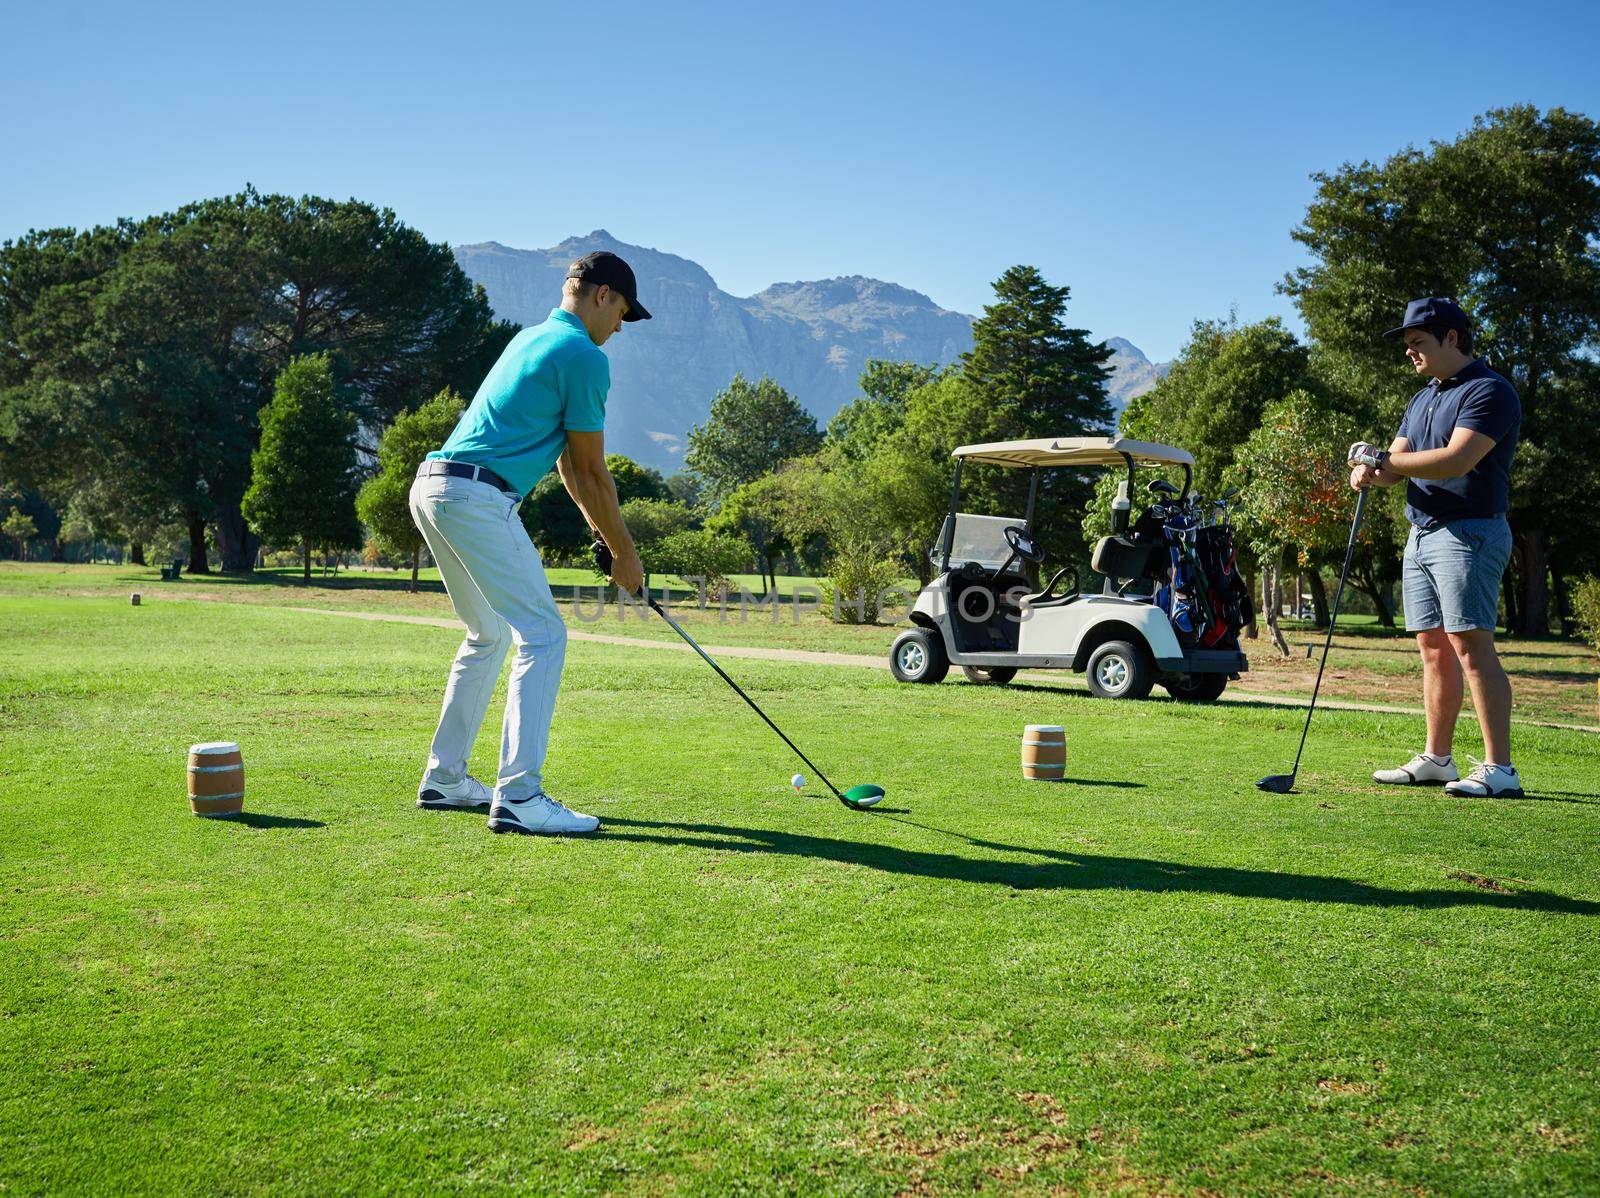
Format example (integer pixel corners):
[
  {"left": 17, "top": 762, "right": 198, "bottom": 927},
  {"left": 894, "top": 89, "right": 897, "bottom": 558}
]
[{"left": 411, "top": 253, "right": 650, "bottom": 835}]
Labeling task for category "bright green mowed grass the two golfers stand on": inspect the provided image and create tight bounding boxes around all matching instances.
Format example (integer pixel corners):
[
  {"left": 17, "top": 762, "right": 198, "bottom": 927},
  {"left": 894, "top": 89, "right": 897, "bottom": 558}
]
[{"left": 0, "top": 593, "right": 1600, "bottom": 1195}]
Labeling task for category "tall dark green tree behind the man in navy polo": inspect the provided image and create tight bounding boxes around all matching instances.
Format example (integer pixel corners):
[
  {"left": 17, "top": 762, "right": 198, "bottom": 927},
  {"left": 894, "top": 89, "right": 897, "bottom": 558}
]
[{"left": 1283, "top": 106, "right": 1600, "bottom": 632}]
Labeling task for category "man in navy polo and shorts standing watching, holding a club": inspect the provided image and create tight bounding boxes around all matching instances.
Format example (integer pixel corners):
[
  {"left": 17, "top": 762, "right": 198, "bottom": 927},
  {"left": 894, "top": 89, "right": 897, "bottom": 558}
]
[{"left": 1350, "top": 296, "right": 1522, "bottom": 797}]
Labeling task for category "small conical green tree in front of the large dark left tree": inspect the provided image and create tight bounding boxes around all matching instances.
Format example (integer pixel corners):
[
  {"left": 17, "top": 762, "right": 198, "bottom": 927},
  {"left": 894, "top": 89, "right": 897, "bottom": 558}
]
[{"left": 240, "top": 353, "right": 362, "bottom": 582}]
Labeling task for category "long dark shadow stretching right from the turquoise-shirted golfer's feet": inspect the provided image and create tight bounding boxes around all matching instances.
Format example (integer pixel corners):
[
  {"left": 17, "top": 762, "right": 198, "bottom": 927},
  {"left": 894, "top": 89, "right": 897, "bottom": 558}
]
[{"left": 602, "top": 817, "right": 1600, "bottom": 915}]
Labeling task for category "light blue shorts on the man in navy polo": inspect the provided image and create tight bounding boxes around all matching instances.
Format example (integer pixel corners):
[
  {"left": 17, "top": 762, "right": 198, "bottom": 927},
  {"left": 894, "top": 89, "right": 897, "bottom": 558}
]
[{"left": 1402, "top": 515, "right": 1510, "bottom": 632}]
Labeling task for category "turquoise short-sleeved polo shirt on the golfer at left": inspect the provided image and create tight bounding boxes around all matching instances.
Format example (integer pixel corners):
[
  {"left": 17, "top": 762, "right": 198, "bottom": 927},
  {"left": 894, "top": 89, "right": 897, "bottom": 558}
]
[{"left": 429, "top": 309, "right": 611, "bottom": 496}]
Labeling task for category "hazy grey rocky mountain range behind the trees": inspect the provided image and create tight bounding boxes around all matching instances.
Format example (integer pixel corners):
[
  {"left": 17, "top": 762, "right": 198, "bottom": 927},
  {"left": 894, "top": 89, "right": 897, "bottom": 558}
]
[{"left": 454, "top": 229, "right": 1165, "bottom": 473}]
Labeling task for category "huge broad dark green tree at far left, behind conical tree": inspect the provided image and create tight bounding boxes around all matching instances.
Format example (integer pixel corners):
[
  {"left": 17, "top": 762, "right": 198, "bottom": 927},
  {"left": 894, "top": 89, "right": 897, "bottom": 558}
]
[{"left": 0, "top": 189, "right": 514, "bottom": 571}]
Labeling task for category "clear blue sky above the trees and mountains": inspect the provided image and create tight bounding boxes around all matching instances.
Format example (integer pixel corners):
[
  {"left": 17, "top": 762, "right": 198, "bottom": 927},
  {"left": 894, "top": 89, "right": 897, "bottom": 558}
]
[{"left": 0, "top": 0, "right": 1600, "bottom": 358}]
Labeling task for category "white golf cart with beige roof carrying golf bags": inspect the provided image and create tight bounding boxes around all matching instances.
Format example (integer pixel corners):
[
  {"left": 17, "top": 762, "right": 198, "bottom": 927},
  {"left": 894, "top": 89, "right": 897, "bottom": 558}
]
[{"left": 890, "top": 437, "right": 1250, "bottom": 702}]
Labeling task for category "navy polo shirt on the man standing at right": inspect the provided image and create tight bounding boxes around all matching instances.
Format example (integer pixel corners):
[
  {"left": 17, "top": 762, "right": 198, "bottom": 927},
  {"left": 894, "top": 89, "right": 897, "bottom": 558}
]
[{"left": 1397, "top": 358, "right": 1522, "bottom": 528}]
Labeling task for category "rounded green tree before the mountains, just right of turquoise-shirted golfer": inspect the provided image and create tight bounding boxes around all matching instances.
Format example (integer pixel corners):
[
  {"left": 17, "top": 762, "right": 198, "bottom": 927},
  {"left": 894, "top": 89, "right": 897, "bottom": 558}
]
[{"left": 683, "top": 374, "right": 822, "bottom": 505}]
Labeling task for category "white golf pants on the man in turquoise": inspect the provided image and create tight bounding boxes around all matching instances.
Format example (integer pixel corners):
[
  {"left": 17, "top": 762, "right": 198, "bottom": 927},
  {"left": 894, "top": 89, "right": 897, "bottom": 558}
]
[{"left": 411, "top": 475, "right": 566, "bottom": 800}]
